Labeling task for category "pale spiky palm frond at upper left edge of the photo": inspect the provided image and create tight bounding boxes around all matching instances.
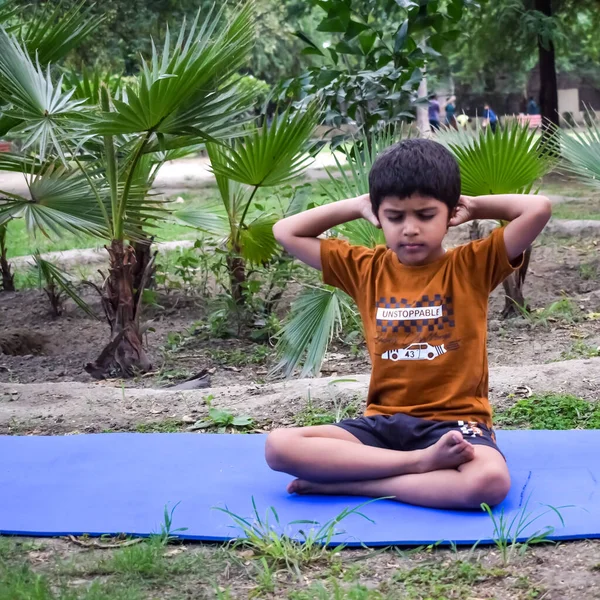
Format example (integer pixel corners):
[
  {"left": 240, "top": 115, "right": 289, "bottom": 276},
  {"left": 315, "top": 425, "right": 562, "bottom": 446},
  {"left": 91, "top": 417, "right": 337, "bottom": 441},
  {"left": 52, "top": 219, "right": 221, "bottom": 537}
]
[{"left": 0, "top": 27, "right": 82, "bottom": 161}]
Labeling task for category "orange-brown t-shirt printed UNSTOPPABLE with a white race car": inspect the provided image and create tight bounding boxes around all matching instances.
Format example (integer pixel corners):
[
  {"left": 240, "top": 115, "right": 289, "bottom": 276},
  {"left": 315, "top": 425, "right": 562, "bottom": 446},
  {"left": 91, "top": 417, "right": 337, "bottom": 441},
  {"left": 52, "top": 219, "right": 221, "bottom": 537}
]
[{"left": 321, "top": 228, "right": 518, "bottom": 426}]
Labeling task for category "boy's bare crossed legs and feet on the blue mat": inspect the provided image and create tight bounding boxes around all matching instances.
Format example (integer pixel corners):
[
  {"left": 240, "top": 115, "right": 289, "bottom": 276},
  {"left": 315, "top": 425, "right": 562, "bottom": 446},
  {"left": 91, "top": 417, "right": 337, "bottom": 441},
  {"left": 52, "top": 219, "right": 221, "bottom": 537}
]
[{"left": 266, "top": 425, "right": 510, "bottom": 508}]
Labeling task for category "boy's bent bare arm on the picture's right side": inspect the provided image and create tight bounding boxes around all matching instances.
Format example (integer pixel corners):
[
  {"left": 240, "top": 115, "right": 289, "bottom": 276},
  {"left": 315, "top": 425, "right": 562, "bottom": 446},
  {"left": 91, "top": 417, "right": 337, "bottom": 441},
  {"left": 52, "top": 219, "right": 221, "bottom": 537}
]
[{"left": 450, "top": 194, "right": 552, "bottom": 260}]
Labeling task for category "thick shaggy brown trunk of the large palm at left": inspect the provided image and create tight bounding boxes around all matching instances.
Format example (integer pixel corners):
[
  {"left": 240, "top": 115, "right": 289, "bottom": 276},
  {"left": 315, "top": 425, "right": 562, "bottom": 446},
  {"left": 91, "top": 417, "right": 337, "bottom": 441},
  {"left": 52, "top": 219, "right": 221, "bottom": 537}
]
[{"left": 85, "top": 240, "right": 152, "bottom": 379}]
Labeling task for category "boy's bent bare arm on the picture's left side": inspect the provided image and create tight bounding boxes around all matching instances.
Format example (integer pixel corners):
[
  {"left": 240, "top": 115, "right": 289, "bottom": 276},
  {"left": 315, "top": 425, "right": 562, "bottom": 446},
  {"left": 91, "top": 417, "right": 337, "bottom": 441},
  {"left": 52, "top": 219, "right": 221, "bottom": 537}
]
[{"left": 273, "top": 194, "right": 379, "bottom": 271}]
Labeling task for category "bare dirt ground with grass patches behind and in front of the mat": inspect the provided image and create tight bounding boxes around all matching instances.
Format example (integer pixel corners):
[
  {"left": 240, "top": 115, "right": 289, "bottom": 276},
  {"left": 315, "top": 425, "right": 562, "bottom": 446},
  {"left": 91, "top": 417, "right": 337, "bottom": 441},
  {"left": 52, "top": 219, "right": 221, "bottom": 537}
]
[{"left": 0, "top": 224, "right": 600, "bottom": 600}]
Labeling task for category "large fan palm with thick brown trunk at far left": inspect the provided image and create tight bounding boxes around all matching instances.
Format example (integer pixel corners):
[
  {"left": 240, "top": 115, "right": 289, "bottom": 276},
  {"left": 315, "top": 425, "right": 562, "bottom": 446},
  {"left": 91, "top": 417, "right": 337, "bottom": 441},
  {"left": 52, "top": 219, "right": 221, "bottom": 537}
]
[{"left": 0, "top": 3, "right": 253, "bottom": 377}]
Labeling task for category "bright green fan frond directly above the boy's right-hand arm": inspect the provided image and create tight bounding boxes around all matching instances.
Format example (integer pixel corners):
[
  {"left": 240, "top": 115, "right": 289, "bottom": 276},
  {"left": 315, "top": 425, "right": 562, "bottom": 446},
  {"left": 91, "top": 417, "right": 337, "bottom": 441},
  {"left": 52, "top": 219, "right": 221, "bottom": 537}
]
[{"left": 446, "top": 122, "right": 557, "bottom": 196}]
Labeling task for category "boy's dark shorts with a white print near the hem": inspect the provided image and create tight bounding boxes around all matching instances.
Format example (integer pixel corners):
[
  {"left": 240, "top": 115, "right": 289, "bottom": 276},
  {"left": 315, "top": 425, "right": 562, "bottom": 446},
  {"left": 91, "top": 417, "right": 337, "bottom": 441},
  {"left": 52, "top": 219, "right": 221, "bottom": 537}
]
[{"left": 336, "top": 413, "right": 504, "bottom": 456}]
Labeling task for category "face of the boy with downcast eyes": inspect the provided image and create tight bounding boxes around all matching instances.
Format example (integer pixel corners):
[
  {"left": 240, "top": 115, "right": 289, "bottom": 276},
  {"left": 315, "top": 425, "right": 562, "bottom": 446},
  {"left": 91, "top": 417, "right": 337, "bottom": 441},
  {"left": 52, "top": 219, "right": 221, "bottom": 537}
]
[{"left": 377, "top": 194, "right": 449, "bottom": 266}]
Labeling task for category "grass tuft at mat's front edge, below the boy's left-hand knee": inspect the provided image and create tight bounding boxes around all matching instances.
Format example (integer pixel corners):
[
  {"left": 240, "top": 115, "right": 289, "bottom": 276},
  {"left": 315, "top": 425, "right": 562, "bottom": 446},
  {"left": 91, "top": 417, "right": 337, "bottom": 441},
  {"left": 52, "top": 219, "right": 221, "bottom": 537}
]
[{"left": 215, "top": 497, "right": 381, "bottom": 577}]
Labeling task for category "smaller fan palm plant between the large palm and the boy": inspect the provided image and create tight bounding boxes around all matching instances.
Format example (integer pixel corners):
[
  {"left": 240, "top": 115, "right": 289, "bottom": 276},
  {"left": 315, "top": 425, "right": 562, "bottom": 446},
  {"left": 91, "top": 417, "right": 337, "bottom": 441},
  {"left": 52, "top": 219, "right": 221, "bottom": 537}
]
[{"left": 175, "top": 104, "right": 319, "bottom": 306}]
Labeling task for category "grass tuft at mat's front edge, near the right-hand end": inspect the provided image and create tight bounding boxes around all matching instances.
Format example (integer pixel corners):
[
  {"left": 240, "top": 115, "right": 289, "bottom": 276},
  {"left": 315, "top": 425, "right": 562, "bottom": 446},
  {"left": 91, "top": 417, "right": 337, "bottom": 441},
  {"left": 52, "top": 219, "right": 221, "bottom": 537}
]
[{"left": 481, "top": 498, "right": 570, "bottom": 566}]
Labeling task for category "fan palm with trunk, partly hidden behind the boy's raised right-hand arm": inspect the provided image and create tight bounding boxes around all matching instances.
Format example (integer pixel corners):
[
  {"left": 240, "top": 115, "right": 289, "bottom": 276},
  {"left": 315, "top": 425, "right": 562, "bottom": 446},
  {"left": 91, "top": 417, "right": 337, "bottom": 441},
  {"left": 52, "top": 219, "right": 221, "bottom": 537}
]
[{"left": 436, "top": 122, "right": 556, "bottom": 317}]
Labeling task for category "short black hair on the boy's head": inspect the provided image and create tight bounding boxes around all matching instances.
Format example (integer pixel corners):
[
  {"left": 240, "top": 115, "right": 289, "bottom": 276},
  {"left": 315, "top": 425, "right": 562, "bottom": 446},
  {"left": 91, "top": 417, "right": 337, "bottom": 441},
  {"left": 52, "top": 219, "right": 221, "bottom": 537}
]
[{"left": 369, "top": 139, "right": 460, "bottom": 214}]
